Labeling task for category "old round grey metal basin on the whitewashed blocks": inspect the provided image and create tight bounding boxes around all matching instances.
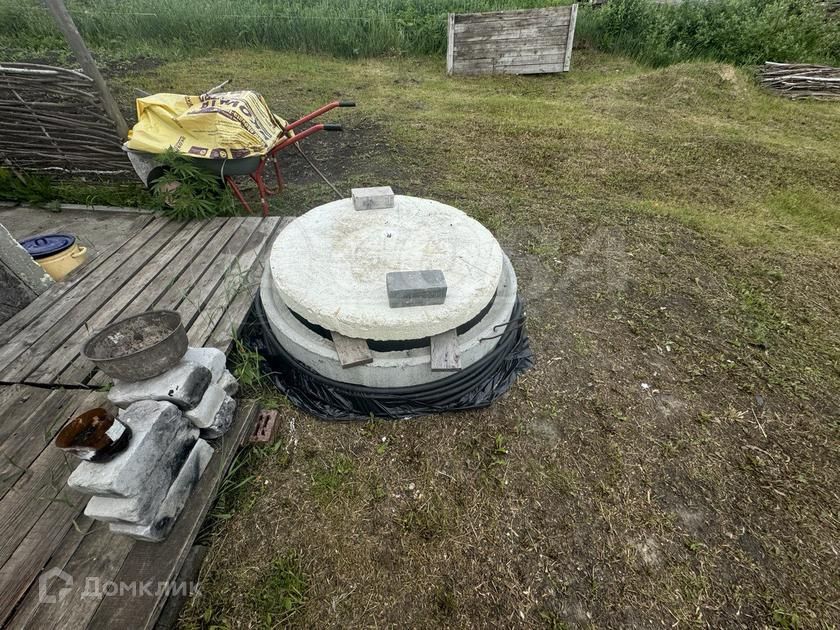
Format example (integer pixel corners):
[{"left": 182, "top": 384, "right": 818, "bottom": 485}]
[{"left": 82, "top": 311, "right": 188, "bottom": 382}]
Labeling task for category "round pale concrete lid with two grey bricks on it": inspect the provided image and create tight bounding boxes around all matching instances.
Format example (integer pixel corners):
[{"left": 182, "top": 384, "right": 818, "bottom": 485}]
[{"left": 270, "top": 195, "right": 504, "bottom": 341}]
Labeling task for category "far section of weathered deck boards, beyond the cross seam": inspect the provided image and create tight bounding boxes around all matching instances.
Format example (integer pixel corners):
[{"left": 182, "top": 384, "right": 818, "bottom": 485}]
[{"left": 0, "top": 217, "right": 283, "bottom": 386}]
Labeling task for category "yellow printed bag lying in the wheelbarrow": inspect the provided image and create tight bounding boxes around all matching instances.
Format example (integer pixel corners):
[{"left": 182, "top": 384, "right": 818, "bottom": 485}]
[{"left": 126, "top": 91, "right": 291, "bottom": 159}]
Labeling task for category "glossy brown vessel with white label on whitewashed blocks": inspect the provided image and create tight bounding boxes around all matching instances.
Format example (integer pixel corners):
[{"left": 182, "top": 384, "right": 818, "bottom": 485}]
[{"left": 55, "top": 407, "right": 131, "bottom": 462}]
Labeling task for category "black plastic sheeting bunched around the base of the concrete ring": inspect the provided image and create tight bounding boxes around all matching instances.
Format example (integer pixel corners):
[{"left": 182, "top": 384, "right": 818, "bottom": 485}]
[{"left": 242, "top": 296, "right": 534, "bottom": 420}]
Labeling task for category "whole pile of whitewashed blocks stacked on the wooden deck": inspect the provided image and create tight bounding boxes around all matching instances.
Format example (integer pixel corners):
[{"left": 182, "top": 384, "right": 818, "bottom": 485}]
[{"left": 68, "top": 348, "right": 238, "bottom": 541}]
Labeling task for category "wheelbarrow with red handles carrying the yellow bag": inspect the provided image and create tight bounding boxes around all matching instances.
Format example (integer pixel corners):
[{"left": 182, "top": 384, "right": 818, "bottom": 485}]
[{"left": 124, "top": 91, "right": 356, "bottom": 216}]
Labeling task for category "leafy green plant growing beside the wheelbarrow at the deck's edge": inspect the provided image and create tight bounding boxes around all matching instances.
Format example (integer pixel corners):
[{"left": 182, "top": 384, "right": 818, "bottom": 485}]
[{"left": 152, "top": 148, "right": 236, "bottom": 220}]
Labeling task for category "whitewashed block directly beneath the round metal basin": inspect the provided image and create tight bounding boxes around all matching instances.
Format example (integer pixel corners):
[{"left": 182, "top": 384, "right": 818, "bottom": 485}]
[{"left": 108, "top": 361, "right": 212, "bottom": 409}]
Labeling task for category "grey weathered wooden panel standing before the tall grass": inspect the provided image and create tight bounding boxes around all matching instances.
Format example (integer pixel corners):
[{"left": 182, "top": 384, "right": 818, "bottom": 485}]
[{"left": 446, "top": 4, "right": 578, "bottom": 74}]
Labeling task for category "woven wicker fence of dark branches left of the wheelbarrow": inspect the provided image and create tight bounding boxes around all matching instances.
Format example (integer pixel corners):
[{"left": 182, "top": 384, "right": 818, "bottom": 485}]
[{"left": 0, "top": 63, "right": 132, "bottom": 176}]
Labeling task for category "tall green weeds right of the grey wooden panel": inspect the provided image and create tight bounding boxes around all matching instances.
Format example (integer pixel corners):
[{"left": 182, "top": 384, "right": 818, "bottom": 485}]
[{"left": 578, "top": 0, "right": 840, "bottom": 66}]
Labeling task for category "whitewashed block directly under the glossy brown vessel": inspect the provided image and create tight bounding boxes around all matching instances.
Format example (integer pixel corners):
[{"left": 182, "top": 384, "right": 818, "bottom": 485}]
[{"left": 67, "top": 400, "right": 189, "bottom": 497}]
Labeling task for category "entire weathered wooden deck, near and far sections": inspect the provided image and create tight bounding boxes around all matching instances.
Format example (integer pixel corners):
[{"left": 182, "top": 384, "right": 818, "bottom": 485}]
[{"left": 0, "top": 216, "right": 288, "bottom": 628}]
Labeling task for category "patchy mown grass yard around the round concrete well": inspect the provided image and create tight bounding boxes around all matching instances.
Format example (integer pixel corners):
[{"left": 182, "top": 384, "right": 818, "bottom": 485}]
[{"left": 117, "top": 51, "right": 840, "bottom": 628}]
